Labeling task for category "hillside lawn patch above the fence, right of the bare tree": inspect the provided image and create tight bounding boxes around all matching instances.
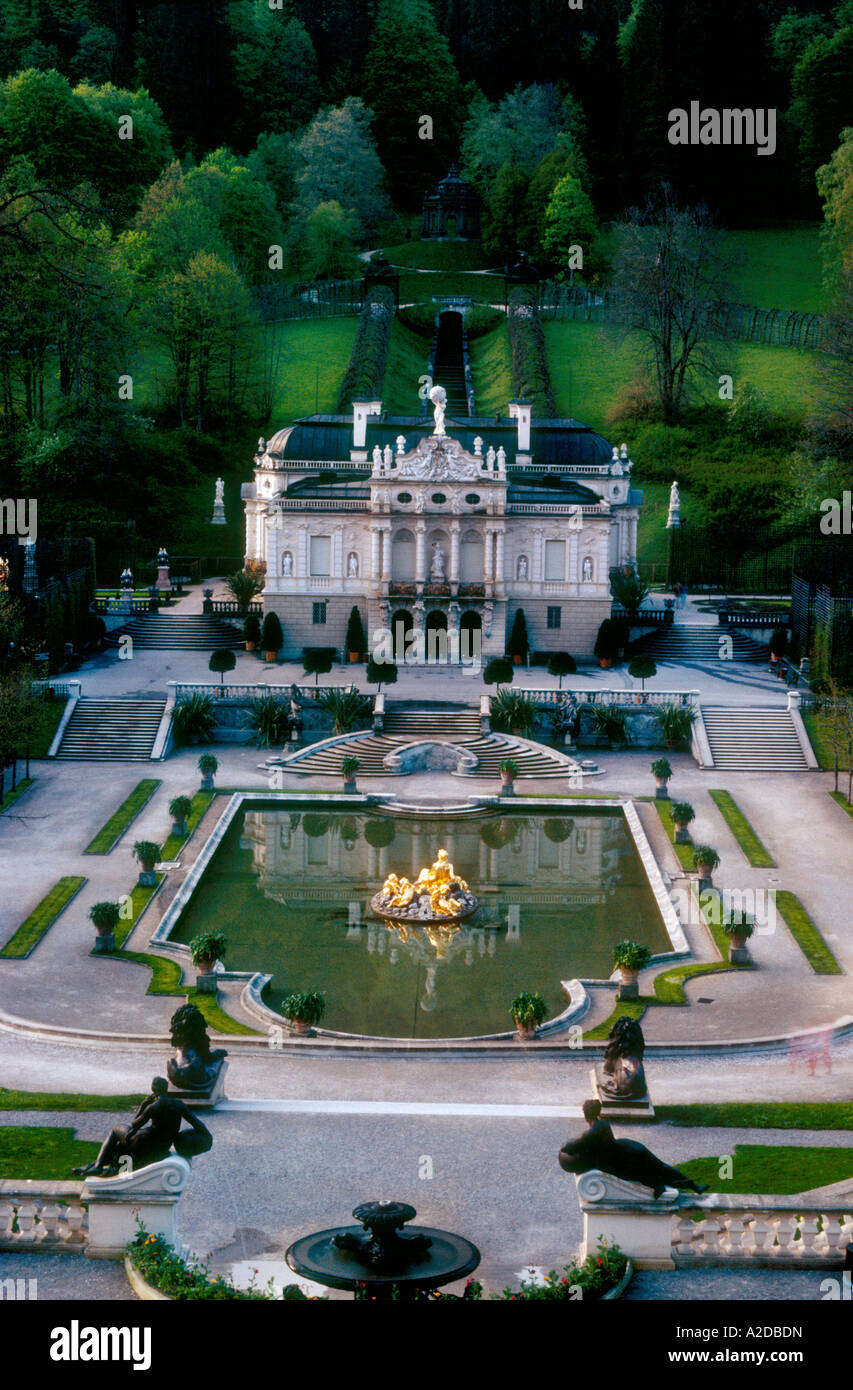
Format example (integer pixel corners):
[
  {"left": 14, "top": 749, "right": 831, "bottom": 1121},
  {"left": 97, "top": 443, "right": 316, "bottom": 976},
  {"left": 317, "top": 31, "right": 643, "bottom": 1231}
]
[{"left": 729, "top": 222, "right": 828, "bottom": 313}]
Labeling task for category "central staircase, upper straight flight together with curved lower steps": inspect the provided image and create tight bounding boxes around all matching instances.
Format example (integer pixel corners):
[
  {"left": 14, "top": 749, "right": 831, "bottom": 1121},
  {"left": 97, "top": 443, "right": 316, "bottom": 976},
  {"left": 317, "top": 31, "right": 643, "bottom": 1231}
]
[{"left": 276, "top": 709, "right": 572, "bottom": 778}]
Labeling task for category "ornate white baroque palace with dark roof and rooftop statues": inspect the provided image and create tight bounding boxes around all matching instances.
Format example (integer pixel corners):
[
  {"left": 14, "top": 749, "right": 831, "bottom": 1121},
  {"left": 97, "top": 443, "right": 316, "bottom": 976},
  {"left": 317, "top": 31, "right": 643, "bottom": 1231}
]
[{"left": 242, "top": 386, "right": 642, "bottom": 660}]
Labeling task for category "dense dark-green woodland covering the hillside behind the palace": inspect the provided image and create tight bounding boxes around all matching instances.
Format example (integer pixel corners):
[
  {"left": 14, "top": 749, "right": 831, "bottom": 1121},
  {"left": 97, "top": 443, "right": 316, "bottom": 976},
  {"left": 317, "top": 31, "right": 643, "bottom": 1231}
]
[{"left": 0, "top": 0, "right": 853, "bottom": 592}]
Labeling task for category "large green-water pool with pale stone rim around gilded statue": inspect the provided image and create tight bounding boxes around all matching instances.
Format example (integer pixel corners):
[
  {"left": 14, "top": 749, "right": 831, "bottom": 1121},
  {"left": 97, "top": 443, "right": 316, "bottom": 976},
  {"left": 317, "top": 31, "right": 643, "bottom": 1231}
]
[{"left": 153, "top": 794, "right": 686, "bottom": 1047}]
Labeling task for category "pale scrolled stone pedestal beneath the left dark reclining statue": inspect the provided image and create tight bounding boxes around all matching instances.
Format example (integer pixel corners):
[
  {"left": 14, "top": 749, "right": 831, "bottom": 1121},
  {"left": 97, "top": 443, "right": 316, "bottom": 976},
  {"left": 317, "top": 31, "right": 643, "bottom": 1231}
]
[{"left": 83, "top": 1154, "right": 190, "bottom": 1259}]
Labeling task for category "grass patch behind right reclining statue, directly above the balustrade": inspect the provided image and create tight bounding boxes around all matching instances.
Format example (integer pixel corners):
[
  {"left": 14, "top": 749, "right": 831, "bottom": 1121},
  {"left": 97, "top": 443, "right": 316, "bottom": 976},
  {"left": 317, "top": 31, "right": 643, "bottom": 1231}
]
[{"left": 678, "top": 1144, "right": 853, "bottom": 1195}]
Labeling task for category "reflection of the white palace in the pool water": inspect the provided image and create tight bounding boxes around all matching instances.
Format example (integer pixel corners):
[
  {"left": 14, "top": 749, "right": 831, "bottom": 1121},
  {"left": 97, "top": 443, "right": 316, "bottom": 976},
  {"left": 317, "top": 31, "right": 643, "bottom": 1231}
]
[{"left": 240, "top": 810, "right": 633, "bottom": 933}]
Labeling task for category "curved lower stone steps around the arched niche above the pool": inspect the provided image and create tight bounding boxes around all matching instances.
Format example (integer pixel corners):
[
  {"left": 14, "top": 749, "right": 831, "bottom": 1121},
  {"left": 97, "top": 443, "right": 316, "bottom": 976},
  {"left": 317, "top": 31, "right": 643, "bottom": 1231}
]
[{"left": 280, "top": 730, "right": 572, "bottom": 778}]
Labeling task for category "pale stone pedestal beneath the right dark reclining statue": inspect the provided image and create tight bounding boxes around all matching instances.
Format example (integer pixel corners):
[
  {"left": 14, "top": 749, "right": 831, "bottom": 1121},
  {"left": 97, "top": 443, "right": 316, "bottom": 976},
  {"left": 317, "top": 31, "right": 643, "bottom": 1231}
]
[{"left": 575, "top": 1169, "right": 680, "bottom": 1269}]
